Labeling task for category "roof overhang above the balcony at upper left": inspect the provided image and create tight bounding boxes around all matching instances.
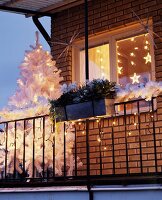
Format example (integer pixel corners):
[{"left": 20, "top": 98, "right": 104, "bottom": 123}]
[{"left": 0, "top": 0, "right": 84, "bottom": 16}]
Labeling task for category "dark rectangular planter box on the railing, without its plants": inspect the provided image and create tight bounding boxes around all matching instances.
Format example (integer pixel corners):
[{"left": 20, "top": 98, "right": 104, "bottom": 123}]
[{"left": 56, "top": 98, "right": 114, "bottom": 121}]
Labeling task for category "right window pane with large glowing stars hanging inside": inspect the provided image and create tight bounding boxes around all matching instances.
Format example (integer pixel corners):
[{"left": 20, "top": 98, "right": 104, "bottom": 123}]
[{"left": 116, "top": 34, "right": 151, "bottom": 86}]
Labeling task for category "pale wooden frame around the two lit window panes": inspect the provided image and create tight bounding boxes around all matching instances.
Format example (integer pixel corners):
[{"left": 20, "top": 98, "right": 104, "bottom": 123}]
[{"left": 72, "top": 20, "right": 155, "bottom": 83}]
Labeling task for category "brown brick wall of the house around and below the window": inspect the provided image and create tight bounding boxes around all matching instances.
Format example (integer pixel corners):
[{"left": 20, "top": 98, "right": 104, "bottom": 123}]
[{"left": 51, "top": 0, "right": 162, "bottom": 175}]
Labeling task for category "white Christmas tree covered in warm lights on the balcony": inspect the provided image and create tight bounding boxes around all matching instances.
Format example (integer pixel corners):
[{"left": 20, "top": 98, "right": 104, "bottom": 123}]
[{"left": 0, "top": 32, "right": 81, "bottom": 177}]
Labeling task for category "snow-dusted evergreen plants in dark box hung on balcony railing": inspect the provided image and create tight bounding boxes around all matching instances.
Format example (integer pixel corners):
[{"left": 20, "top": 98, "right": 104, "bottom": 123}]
[{"left": 50, "top": 79, "right": 116, "bottom": 121}]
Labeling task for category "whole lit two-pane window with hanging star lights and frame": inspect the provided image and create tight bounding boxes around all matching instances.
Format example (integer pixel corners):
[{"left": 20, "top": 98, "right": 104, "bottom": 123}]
[{"left": 73, "top": 25, "right": 155, "bottom": 87}]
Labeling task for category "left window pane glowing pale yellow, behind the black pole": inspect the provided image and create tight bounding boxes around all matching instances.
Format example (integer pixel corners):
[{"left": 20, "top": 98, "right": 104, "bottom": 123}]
[{"left": 80, "top": 44, "right": 110, "bottom": 82}]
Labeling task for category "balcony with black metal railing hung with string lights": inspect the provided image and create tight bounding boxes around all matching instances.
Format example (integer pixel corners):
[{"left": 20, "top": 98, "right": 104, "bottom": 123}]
[{"left": 0, "top": 96, "right": 162, "bottom": 187}]
